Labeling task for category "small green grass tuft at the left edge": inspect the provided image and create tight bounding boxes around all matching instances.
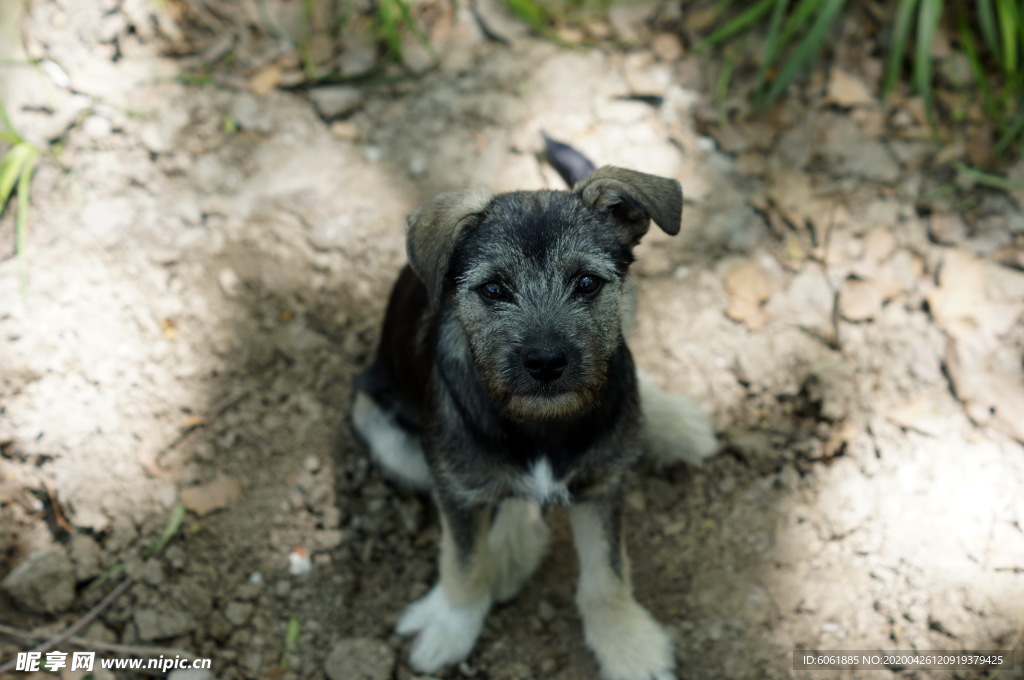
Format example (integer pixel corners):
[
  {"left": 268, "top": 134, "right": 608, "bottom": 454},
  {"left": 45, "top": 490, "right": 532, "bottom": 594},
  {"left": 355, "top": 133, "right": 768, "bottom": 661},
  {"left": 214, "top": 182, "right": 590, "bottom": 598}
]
[{"left": 0, "top": 102, "right": 42, "bottom": 299}]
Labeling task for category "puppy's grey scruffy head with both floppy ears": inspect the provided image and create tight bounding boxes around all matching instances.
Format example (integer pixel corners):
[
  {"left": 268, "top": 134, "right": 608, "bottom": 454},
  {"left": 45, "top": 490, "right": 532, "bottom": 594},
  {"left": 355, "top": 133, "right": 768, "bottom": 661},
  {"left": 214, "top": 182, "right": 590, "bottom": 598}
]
[{"left": 408, "top": 167, "right": 683, "bottom": 420}]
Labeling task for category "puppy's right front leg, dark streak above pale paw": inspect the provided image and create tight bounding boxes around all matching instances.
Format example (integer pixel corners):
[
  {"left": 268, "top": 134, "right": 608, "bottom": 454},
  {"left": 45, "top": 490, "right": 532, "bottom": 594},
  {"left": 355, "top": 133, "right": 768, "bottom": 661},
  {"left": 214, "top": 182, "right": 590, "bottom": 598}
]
[{"left": 569, "top": 491, "right": 676, "bottom": 680}]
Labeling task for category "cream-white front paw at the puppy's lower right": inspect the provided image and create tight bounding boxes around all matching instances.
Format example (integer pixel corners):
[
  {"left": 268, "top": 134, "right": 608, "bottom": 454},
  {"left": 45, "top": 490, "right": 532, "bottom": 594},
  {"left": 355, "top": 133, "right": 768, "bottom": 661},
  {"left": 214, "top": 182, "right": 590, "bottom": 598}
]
[{"left": 583, "top": 599, "right": 676, "bottom": 680}]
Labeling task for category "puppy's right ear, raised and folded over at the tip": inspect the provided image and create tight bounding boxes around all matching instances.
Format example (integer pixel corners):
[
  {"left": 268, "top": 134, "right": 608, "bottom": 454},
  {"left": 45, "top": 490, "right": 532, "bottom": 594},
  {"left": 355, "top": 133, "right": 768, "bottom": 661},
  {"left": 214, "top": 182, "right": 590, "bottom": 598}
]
[{"left": 574, "top": 165, "right": 683, "bottom": 244}]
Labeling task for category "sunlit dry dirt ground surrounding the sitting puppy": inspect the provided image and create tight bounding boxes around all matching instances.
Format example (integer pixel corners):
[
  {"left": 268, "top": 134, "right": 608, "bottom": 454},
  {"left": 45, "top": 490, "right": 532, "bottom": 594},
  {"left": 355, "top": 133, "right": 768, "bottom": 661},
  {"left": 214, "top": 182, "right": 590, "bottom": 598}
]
[{"left": 0, "top": 0, "right": 1024, "bottom": 680}]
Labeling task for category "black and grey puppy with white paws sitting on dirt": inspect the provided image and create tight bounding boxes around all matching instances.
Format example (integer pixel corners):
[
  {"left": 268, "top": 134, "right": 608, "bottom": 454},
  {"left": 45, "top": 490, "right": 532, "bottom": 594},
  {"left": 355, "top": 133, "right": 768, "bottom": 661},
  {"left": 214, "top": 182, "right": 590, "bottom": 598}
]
[{"left": 352, "top": 150, "right": 717, "bottom": 680}]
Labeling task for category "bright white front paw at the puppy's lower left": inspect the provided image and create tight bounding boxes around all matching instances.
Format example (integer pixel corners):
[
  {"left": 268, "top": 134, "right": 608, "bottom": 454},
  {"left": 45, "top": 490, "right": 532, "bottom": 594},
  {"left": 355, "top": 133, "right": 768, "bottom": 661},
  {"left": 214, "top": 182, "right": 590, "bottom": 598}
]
[{"left": 395, "top": 584, "right": 490, "bottom": 673}]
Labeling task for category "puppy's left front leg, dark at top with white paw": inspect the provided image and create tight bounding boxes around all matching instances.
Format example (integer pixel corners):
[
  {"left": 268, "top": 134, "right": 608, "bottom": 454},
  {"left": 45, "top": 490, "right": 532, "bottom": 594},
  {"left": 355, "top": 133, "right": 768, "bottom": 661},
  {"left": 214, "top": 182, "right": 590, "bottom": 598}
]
[{"left": 396, "top": 497, "right": 494, "bottom": 673}]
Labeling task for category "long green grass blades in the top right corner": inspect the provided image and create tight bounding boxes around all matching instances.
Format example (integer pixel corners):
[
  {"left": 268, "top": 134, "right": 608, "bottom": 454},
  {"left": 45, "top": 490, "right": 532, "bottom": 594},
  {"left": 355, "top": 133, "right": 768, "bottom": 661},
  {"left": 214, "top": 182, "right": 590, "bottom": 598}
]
[{"left": 695, "top": 0, "right": 1024, "bottom": 158}]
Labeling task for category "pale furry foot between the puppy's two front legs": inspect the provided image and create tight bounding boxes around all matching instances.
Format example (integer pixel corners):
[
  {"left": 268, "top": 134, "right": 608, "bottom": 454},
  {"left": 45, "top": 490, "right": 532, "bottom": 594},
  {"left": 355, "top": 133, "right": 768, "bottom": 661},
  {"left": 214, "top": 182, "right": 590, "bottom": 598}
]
[{"left": 487, "top": 499, "right": 551, "bottom": 602}]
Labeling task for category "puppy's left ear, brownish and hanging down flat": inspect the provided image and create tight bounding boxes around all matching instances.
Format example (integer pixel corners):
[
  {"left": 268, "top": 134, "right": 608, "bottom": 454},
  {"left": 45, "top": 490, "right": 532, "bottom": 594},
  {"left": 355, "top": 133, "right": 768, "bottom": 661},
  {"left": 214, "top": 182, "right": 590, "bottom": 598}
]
[{"left": 406, "top": 188, "right": 492, "bottom": 306}]
